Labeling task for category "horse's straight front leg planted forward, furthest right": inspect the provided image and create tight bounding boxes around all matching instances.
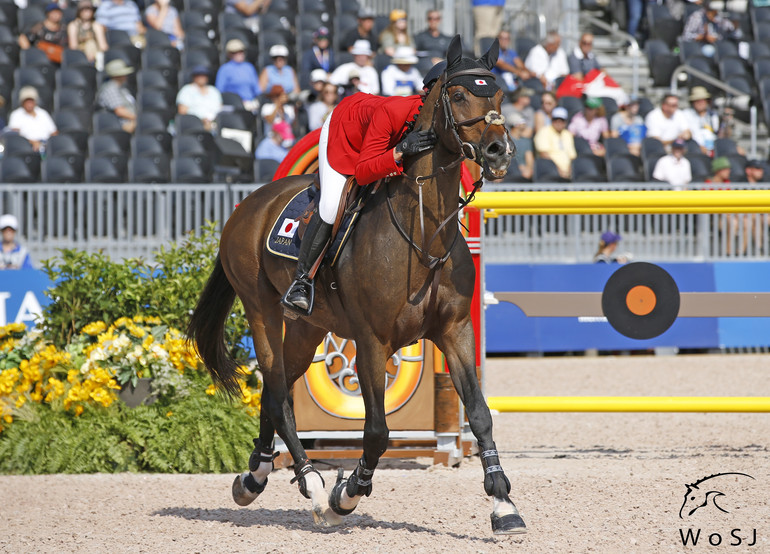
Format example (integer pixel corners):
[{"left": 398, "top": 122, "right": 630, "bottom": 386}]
[{"left": 435, "top": 319, "right": 527, "bottom": 534}]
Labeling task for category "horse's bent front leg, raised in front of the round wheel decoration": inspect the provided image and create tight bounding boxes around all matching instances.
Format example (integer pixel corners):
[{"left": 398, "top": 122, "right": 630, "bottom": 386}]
[{"left": 329, "top": 339, "right": 389, "bottom": 515}]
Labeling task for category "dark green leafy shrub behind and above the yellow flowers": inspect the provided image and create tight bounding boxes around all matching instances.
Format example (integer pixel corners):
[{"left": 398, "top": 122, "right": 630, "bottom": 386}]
[{"left": 40, "top": 223, "right": 249, "bottom": 361}]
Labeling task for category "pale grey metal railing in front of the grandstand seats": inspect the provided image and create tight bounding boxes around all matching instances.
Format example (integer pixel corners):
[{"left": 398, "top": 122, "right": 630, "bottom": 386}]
[{"left": 0, "top": 183, "right": 770, "bottom": 263}]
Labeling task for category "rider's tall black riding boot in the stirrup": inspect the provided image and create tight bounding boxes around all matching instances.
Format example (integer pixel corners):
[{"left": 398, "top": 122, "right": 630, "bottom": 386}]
[{"left": 281, "top": 212, "right": 332, "bottom": 315}]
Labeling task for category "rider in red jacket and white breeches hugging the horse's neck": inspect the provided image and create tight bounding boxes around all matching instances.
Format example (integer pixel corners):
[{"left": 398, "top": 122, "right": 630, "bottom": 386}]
[{"left": 282, "top": 62, "right": 446, "bottom": 315}]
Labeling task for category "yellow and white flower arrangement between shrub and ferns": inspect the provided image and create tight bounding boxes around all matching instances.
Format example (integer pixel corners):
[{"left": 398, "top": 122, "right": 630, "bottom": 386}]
[{"left": 0, "top": 316, "right": 262, "bottom": 432}]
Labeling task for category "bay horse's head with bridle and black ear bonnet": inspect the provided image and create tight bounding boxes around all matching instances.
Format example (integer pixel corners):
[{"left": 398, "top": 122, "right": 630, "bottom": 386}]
[{"left": 425, "top": 35, "right": 515, "bottom": 179}]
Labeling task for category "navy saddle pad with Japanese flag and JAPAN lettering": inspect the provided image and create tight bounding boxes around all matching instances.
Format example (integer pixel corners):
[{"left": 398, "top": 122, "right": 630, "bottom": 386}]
[{"left": 267, "top": 185, "right": 361, "bottom": 265}]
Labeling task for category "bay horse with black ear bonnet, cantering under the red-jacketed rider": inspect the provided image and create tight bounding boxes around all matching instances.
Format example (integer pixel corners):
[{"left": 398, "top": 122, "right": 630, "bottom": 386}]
[{"left": 188, "top": 35, "right": 526, "bottom": 534}]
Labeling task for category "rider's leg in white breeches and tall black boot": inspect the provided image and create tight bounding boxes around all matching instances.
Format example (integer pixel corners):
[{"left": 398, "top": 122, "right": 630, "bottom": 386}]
[{"left": 284, "top": 115, "right": 346, "bottom": 315}]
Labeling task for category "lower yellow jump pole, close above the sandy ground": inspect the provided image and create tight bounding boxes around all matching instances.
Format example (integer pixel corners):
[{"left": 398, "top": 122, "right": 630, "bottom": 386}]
[{"left": 487, "top": 396, "right": 770, "bottom": 413}]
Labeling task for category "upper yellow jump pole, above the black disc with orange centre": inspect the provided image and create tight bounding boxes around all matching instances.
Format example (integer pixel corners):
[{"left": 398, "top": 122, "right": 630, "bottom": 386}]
[{"left": 471, "top": 190, "right": 770, "bottom": 217}]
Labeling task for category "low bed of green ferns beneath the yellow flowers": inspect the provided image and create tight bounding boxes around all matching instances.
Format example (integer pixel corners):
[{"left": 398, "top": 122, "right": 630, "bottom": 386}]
[{"left": 0, "top": 390, "right": 259, "bottom": 474}]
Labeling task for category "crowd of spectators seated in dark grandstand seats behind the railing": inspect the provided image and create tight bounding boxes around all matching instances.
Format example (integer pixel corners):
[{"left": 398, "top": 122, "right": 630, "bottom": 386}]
[{"left": 0, "top": 0, "right": 761, "bottom": 188}]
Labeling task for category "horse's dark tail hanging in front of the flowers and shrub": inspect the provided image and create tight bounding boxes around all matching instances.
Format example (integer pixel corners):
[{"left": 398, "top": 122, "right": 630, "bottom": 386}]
[{"left": 187, "top": 255, "right": 241, "bottom": 396}]
